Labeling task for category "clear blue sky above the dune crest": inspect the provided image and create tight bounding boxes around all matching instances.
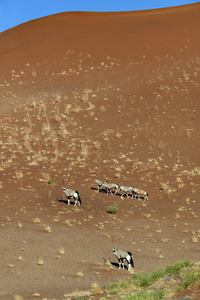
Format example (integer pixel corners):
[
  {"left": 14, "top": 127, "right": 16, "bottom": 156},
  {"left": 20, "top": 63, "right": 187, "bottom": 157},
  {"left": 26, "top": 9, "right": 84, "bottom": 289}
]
[{"left": 0, "top": 0, "right": 198, "bottom": 32}]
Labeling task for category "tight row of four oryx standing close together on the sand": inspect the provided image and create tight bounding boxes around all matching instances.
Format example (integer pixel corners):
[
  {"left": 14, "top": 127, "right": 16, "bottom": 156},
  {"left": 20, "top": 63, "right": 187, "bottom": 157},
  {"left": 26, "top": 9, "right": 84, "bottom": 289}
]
[{"left": 94, "top": 177, "right": 149, "bottom": 200}]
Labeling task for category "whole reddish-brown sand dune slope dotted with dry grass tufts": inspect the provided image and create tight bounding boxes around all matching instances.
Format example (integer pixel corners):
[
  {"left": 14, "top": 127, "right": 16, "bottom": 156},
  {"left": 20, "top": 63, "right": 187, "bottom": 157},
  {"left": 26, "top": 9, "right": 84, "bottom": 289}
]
[{"left": 0, "top": 3, "right": 200, "bottom": 299}]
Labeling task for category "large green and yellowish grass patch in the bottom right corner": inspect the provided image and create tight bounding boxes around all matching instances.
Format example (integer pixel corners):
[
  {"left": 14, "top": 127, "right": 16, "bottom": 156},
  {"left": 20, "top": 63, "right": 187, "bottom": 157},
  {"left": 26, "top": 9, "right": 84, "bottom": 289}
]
[{"left": 76, "top": 259, "right": 200, "bottom": 300}]
